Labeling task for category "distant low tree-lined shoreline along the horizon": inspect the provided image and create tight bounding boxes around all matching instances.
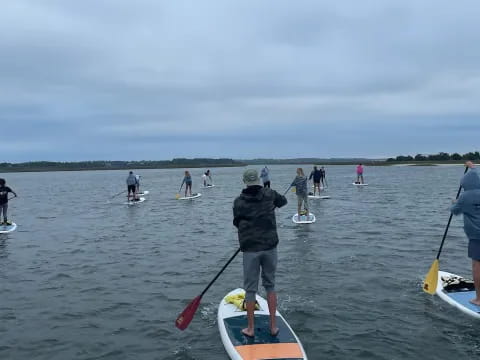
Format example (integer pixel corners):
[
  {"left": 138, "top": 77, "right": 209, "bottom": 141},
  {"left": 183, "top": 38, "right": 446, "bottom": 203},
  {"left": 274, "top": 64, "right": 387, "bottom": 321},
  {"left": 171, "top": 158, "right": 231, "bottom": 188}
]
[{"left": 0, "top": 158, "right": 464, "bottom": 173}]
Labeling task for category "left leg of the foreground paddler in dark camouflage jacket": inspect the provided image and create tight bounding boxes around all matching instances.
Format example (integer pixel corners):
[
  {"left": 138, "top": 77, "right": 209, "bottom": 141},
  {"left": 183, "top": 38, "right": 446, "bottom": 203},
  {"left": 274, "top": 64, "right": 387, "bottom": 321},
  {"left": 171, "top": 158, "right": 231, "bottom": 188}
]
[{"left": 242, "top": 252, "right": 260, "bottom": 336}]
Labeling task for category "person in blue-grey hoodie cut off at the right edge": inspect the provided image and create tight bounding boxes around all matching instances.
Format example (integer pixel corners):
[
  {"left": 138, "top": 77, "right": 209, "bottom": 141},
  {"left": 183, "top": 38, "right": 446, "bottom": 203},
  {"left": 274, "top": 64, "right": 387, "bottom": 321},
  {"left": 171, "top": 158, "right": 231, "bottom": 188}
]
[{"left": 450, "top": 161, "right": 480, "bottom": 306}]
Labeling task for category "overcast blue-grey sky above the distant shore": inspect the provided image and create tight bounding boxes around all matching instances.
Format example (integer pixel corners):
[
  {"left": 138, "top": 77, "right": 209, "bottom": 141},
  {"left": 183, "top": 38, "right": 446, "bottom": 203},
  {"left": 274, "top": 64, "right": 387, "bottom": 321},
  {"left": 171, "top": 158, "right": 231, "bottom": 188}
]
[{"left": 0, "top": 0, "right": 480, "bottom": 162}]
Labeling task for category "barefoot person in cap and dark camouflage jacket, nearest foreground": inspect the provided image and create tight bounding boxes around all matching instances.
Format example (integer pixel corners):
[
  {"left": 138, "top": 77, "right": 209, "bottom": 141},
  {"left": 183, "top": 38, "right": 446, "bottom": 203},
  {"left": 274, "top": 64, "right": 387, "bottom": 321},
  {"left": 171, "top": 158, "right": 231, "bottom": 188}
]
[{"left": 233, "top": 169, "right": 287, "bottom": 337}]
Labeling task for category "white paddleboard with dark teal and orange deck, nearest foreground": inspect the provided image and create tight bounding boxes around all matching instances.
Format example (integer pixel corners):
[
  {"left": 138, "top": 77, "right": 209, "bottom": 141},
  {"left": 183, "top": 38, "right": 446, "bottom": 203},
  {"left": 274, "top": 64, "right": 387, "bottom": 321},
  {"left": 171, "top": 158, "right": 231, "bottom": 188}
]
[{"left": 218, "top": 289, "right": 307, "bottom": 360}]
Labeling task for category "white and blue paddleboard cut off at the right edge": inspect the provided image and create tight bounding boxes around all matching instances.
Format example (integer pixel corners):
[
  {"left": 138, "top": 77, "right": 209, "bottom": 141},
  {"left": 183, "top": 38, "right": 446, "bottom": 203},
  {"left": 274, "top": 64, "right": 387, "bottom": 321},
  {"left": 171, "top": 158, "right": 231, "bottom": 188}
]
[{"left": 437, "top": 271, "right": 480, "bottom": 319}]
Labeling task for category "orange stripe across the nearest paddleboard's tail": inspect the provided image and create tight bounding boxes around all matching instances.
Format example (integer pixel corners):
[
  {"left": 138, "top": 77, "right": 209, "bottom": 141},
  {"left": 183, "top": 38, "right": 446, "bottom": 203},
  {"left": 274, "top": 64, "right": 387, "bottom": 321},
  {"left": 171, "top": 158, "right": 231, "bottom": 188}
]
[{"left": 235, "top": 343, "right": 303, "bottom": 360}]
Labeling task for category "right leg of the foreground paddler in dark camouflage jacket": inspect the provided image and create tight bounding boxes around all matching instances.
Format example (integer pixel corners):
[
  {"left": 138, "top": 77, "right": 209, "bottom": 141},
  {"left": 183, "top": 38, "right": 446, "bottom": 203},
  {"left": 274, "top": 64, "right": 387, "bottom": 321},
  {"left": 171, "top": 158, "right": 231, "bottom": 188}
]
[{"left": 261, "top": 248, "right": 278, "bottom": 336}]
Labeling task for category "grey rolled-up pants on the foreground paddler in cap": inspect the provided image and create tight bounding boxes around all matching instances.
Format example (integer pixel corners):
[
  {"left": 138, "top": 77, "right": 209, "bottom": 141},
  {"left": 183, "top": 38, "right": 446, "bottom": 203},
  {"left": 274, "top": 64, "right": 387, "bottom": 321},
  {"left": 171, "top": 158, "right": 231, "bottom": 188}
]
[{"left": 243, "top": 248, "right": 277, "bottom": 301}]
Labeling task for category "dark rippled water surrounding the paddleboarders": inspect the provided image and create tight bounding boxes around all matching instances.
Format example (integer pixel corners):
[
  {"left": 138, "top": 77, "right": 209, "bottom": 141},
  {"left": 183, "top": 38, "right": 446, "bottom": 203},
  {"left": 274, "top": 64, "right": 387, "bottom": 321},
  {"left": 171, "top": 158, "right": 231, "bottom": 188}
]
[{"left": 0, "top": 166, "right": 480, "bottom": 360}]
